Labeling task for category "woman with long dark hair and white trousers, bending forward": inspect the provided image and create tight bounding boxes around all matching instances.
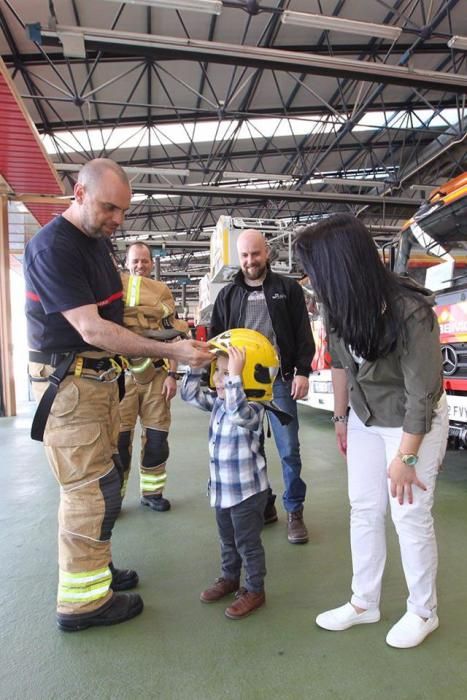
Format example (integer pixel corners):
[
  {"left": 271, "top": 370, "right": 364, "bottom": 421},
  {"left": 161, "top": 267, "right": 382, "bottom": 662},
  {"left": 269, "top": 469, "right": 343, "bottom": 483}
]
[{"left": 295, "top": 214, "right": 448, "bottom": 648}]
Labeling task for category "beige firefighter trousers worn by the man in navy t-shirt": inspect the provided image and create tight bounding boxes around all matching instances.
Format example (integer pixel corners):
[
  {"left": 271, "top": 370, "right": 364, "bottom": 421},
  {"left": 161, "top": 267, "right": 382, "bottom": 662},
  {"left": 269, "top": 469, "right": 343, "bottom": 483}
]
[{"left": 29, "top": 353, "right": 121, "bottom": 614}]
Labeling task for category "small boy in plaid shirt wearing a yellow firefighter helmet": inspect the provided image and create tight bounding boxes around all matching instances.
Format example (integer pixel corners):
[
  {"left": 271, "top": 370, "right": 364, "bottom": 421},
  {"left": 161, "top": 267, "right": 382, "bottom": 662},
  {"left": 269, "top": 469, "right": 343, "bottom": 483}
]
[{"left": 181, "top": 329, "right": 279, "bottom": 620}]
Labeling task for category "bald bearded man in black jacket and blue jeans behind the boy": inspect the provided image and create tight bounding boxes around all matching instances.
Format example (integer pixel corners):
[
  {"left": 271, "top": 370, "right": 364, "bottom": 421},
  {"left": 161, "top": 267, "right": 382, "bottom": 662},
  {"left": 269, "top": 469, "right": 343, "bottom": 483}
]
[{"left": 210, "top": 229, "right": 315, "bottom": 544}]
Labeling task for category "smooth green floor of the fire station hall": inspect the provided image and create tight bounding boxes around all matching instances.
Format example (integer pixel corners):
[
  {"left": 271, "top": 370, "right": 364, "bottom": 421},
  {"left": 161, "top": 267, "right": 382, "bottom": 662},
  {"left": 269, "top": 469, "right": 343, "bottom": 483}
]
[{"left": 0, "top": 399, "right": 467, "bottom": 700}]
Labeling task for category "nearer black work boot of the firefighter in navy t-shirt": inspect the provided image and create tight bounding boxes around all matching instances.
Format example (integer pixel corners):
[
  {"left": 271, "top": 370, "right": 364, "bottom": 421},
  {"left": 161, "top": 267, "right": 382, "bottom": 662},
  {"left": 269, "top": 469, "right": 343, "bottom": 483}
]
[{"left": 57, "top": 593, "right": 144, "bottom": 632}]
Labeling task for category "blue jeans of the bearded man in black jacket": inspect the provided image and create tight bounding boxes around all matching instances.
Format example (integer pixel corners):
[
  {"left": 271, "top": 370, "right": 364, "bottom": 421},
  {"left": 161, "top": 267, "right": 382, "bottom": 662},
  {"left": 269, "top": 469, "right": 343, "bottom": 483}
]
[{"left": 268, "top": 377, "right": 306, "bottom": 513}]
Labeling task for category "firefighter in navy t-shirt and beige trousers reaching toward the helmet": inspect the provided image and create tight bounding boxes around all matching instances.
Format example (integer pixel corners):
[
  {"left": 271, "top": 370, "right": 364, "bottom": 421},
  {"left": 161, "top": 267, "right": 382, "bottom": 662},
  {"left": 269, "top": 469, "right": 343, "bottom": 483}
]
[{"left": 24, "top": 159, "right": 211, "bottom": 631}]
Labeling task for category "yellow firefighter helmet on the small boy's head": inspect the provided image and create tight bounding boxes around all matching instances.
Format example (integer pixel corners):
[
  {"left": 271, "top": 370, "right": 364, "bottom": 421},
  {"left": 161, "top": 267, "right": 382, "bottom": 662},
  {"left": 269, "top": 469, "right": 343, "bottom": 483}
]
[{"left": 209, "top": 328, "right": 280, "bottom": 401}]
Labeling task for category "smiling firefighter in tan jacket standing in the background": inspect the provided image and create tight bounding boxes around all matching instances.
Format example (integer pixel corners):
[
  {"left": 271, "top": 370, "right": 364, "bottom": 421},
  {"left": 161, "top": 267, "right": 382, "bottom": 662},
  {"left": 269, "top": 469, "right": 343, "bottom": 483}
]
[{"left": 118, "top": 243, "right": 188, "bottom": 512}]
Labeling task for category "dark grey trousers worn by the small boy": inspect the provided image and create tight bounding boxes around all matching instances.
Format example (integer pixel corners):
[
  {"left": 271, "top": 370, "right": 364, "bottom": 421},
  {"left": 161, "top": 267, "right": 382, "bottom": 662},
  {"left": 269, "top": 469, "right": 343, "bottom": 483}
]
[{"left": 216, "top": 491, "right": 268, "bottom": 593}]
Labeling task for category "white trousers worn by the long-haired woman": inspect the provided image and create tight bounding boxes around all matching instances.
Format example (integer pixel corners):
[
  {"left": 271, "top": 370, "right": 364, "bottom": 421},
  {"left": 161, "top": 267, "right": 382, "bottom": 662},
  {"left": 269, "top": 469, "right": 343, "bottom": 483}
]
[{"left": 347, "top": 395, "right": 448, "bottom": 618}]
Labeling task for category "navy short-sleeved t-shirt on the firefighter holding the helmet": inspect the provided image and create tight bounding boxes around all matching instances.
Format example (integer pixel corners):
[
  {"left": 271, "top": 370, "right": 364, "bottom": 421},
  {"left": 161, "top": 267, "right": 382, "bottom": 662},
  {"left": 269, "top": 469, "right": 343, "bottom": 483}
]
[{"left": 24, "top": 216, "right": 123, "bottom": 352}]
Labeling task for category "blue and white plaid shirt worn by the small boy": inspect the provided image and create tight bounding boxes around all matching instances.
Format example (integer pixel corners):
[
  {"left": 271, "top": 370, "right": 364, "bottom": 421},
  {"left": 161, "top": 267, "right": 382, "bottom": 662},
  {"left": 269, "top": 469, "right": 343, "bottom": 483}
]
[{"left": 180, "top": 370, "right": 269, "bottom": 508}]
